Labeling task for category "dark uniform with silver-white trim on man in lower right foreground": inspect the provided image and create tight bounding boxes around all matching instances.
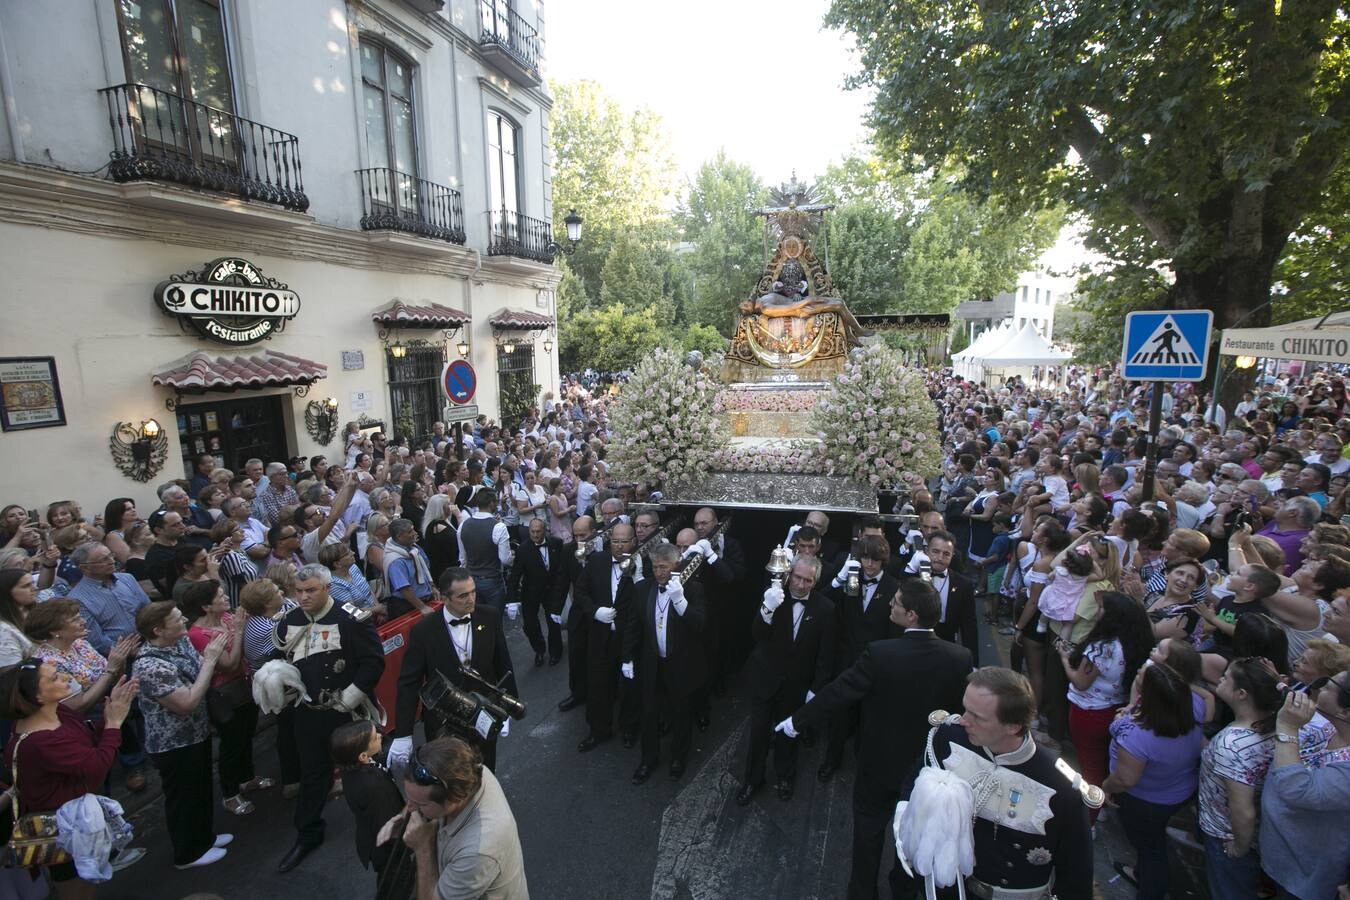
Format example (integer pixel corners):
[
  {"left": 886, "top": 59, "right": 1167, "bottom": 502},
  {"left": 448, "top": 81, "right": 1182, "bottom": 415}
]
[{"left": 896, "top": 712, "right": 1100, "bottom": 900}]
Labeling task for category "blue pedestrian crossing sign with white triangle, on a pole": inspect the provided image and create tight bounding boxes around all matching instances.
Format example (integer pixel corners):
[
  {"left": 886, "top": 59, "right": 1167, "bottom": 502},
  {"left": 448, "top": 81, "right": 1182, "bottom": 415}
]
[{"left": 1121, "top": 309, "right": 1214, "bottom": 382}]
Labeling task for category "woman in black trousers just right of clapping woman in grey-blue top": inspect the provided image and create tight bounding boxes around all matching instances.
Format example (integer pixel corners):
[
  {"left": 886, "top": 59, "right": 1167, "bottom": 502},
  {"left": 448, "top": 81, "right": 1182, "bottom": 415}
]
[{"left": 178, "top": 580, "right": 263, "bottom": 815}]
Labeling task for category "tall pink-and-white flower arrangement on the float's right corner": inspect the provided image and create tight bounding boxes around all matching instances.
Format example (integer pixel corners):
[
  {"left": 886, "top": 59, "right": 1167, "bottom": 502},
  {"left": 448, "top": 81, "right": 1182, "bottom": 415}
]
[{"left": 811, "top": 344, "right": 942, "bottom": 487}]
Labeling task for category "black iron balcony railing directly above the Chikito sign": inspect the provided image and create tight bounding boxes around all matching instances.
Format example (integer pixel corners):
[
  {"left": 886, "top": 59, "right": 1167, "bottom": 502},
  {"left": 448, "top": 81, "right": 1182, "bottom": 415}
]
[{"left": 99, "top": 84, "right": 309, "bottom": 212}]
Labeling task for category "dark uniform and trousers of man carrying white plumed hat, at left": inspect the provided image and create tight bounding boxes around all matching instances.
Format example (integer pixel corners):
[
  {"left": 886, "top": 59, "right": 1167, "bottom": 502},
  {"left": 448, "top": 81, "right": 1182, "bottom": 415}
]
[{"left": 275, "top": 599, "right": 385, "bottom": 846}]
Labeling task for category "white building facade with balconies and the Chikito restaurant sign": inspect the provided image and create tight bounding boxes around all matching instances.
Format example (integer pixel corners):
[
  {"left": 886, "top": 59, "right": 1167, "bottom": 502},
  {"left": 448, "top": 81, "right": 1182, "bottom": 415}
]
[{"left": 0, "top": 0, "right": 559, "bottom": 511}]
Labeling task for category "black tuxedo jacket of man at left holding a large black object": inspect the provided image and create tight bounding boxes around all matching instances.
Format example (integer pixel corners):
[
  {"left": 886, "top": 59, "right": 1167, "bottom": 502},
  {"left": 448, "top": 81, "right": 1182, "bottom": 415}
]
[{"left": 394, "top": 606, "right": 520, "bottom": 738}]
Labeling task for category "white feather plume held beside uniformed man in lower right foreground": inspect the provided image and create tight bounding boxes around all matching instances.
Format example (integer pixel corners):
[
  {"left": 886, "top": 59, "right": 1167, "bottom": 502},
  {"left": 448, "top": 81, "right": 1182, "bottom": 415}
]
[{"left": 895, "top": 766, "right": 975, "bottom": 888}]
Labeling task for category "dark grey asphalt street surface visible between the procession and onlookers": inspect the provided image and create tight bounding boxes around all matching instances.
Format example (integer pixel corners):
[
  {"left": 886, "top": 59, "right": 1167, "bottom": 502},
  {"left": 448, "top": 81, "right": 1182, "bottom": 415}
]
[{"left": 99, "top": 609, "right": 1204, "bottom": 900}]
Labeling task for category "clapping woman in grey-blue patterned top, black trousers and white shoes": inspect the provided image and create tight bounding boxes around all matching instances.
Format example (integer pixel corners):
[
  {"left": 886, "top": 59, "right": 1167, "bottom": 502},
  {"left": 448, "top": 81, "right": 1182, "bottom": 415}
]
[{"left": 132, "top": 600, "right": 234, "bottom": 869}]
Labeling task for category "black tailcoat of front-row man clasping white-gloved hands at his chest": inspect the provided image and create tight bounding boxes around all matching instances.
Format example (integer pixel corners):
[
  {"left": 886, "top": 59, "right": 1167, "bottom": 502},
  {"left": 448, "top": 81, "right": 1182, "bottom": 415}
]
[{"left": 624, "top": 579, "right": 707, "bottom": 708}]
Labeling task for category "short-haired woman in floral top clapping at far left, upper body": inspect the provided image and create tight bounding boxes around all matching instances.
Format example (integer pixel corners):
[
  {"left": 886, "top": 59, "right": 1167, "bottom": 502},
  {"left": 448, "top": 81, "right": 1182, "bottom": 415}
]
[{"left": 23, "top": 596, "right": 140, "bottom": 718}]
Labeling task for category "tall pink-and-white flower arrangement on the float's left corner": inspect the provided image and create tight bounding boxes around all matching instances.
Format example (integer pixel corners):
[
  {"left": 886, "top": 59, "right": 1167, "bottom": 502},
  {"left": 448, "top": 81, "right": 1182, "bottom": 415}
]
[{"left": 609, "top": 348, "right": 728, "bottom": 484}]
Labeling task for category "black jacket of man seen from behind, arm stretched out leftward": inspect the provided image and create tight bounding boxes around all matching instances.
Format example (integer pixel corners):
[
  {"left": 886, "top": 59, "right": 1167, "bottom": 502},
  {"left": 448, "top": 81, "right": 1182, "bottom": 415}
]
[{"left": 792, "top": 631, "right": 973, "bottom": 796}]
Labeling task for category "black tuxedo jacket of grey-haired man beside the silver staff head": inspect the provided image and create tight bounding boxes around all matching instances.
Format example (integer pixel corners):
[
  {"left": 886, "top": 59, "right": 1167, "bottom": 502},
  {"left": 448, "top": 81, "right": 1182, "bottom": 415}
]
[{"left": 749, "top": 591, "right": 834, "bottom": 700}]
